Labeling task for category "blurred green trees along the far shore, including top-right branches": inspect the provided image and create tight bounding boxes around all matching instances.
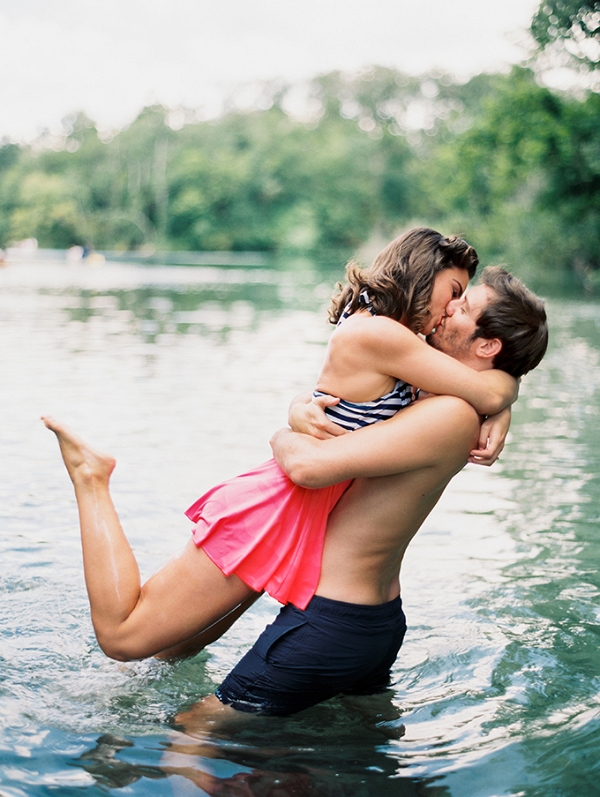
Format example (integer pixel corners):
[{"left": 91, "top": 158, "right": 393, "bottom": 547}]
[{"left": 0, "top": 0, "right": 600, "bottom": 274}]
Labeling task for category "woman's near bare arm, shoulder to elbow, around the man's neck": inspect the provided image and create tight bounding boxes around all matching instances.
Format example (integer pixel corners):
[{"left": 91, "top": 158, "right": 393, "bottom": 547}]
[{"left": 344, "top": 316, "right": 518, "bottom": 415}]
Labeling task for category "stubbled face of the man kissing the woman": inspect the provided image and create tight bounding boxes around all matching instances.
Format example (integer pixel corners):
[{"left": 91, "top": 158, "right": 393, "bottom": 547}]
[{"left": 427, "top": 285, "right": 494, "bottom": 362}]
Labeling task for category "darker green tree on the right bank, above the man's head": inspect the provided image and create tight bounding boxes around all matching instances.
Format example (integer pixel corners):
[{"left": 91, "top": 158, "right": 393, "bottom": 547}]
[{"left": 421, "top": 68, "right": 600, "bottom": 272}]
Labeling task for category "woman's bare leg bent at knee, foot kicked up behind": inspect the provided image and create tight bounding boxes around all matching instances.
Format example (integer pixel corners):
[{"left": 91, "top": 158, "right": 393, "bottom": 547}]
[{"left": 43, "top": 417, "right": 256, "bottom": 661}]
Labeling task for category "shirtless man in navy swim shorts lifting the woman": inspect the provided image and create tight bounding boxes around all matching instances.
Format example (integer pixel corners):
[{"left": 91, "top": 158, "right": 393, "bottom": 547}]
[{"left": 179, "top": 267, "right": 548, "bottom": 729}]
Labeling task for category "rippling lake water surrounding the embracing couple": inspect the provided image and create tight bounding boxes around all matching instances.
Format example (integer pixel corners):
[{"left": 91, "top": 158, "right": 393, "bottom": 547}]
[{"left": 0, "top": 261, "right": 600, "bottom": 797}]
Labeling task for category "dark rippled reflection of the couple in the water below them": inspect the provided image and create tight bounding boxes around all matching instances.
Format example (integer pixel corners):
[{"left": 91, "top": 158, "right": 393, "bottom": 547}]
[{"left": 73, "top": 698, "right": 440, "bottom": 797}]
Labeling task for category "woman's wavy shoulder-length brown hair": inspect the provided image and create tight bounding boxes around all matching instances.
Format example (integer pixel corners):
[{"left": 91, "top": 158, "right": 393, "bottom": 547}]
[{"left": 329, "top": 227, "right": 479, "bottom": 332}]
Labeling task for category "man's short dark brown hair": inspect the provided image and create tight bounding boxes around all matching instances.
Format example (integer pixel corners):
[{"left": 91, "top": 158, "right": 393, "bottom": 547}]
[{"left": 473, "top": 266, "right": 548, "bottom": 377}]
